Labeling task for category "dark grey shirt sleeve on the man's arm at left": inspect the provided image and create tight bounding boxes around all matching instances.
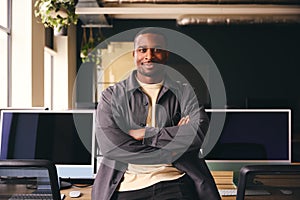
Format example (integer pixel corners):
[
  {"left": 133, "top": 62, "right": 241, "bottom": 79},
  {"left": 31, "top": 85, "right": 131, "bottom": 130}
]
[{"left": 96, "top": 88, "right": 172, "bottom": 164}]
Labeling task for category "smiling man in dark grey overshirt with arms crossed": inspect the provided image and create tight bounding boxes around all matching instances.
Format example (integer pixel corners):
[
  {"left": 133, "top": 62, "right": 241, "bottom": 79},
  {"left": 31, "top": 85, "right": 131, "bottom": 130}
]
[{"left": 92, "top": 28, "right": 220, "bottom": 200}]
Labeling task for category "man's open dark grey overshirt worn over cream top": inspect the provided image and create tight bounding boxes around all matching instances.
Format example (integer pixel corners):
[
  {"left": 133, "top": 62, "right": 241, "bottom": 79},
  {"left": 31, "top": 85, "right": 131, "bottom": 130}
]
[{"left": 92, "top": 71, "right": 220, "bottom": 200}]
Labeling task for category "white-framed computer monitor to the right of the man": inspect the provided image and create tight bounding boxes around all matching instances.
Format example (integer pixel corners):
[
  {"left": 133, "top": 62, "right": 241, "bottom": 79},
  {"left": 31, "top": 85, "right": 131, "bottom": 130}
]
[{"left": 205, "top": 109, "right": 291, "bottom": 171}]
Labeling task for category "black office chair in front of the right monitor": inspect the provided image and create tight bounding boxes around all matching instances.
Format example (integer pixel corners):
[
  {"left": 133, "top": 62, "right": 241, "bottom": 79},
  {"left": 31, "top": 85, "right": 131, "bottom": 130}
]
[{"left": 236, "top": 164, "right": 300, "bottom": 200}]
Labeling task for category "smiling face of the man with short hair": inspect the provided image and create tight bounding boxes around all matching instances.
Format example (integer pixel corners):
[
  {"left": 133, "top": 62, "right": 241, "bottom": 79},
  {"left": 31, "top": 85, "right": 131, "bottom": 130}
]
[{"left": 133, "top": 33, "right": 169, "bottom": 78}]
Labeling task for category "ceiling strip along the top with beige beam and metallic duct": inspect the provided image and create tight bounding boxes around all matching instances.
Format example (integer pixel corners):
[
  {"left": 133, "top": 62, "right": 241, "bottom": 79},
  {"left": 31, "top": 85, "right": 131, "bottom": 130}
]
[{"left": 76, "top": 0, "right": 300, "bottom": 26}]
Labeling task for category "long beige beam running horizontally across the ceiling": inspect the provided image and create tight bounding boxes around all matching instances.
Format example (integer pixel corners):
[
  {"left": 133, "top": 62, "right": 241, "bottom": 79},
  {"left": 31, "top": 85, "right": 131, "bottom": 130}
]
[{"left": 76, "top": 4, "right": 300, "bottom": 19}]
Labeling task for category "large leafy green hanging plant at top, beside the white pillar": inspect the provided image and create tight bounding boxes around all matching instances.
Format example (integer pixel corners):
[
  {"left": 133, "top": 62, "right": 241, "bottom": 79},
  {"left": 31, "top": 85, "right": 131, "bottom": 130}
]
[{"left": 34, "top": 0, "right": 78, "bottom": 35}]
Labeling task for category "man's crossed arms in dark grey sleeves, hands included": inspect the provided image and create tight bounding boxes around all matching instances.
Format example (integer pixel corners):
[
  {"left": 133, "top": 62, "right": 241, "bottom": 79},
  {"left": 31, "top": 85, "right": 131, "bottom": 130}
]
[{"left": 96, "top": 84, "right": 208, "bottom": 164}]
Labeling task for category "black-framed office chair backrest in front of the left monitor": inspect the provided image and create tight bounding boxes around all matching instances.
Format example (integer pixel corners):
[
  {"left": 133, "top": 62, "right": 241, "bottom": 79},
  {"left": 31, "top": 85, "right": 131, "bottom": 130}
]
[{"left": 0, "top": 159, "right": 60, "bottom": 200}]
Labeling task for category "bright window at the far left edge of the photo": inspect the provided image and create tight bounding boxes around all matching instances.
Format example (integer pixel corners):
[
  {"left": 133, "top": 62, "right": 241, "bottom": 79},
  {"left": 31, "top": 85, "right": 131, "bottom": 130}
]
[{"left": 0, "top": 0, "right": 11, "bottom": 107}]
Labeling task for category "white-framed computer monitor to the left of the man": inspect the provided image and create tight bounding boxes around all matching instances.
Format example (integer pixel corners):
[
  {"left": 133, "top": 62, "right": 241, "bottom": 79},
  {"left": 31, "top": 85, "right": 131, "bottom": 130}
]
[{"left": 0, "top": 110, "right": 95, "bottom": 179}]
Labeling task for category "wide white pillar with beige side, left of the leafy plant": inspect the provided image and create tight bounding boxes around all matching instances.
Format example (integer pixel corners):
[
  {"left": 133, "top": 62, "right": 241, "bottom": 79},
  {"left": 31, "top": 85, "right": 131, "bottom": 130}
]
[{"left": 10, "top": 0, "right": 44, "bottom": 107}]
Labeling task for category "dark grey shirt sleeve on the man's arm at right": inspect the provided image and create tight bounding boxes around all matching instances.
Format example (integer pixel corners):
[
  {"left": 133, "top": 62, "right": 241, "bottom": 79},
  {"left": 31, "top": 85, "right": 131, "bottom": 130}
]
[{"left": 143, "top": 82, "right": 209, "bottom": 155}]
